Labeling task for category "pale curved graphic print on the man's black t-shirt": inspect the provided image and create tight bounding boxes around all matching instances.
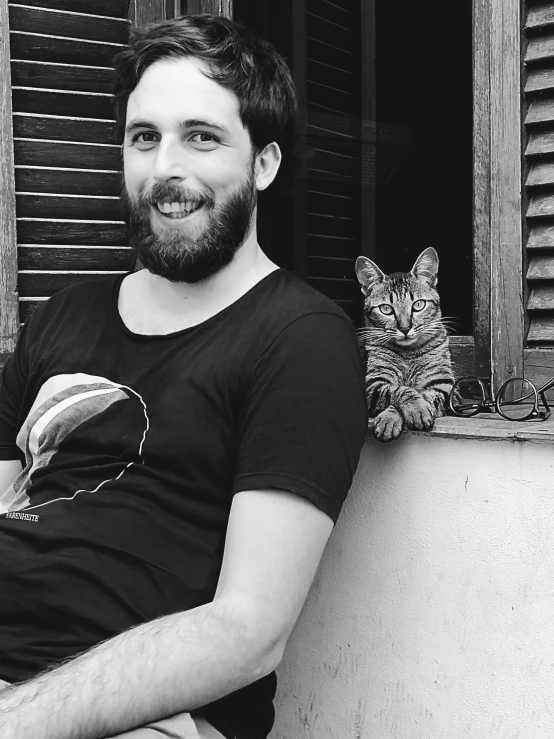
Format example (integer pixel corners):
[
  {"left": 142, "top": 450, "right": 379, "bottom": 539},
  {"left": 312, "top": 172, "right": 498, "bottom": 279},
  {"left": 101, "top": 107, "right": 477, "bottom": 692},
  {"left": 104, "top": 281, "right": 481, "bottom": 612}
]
[{"left": 2, "top": 373, "right": 149, "bottom": 515}]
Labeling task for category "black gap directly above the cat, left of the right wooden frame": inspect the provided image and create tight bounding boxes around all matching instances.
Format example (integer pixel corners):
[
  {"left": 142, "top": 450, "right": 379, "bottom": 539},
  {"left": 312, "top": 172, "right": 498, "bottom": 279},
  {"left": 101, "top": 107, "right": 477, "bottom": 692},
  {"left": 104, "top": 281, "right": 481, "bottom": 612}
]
[{"left": 375, "top": 0, "right": 473, "bottom": 335}]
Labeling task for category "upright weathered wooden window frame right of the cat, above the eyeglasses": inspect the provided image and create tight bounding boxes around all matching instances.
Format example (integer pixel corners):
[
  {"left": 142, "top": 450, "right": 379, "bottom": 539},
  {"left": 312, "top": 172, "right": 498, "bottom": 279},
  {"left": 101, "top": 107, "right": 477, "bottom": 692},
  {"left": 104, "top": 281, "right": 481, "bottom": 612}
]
[{"left": 444, "top": 0, "right": 529, "bottom": 388}]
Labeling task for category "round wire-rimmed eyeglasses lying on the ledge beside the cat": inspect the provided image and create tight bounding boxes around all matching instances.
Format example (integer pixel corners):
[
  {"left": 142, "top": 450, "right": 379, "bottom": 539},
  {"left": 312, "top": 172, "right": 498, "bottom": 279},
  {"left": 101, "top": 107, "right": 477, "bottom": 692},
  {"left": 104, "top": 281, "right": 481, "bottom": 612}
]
[{"left": 448, "top": 375, "right": 554, "bottom": 421}]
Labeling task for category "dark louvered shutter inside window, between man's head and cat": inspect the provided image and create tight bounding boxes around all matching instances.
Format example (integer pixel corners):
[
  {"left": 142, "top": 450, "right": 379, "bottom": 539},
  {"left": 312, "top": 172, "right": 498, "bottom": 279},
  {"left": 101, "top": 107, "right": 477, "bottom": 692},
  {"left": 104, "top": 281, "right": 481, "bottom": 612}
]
[{"left": 302, "top": 0, "right": 362, "bottom": 318}]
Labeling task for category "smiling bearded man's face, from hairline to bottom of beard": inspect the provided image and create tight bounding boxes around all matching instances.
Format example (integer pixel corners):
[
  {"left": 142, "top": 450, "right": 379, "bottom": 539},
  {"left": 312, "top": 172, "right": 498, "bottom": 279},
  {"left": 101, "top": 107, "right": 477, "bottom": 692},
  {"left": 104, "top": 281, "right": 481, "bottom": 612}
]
[{"left": 124, "top": 58, "right": 256, "bottom": 282}]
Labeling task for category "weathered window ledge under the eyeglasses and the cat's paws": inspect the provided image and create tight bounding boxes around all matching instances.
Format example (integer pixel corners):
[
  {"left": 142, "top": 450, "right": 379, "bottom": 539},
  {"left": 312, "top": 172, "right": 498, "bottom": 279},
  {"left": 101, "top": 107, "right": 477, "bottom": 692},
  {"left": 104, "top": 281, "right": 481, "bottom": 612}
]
[{"left": 369, "top": 413, "right": 554, "bottom": 444}]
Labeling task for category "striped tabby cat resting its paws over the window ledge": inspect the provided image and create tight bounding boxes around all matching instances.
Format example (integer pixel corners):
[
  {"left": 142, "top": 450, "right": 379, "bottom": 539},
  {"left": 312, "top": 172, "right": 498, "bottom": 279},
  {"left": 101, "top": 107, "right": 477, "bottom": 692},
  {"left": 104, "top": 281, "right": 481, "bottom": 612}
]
[{"left": 356, "top": 247, "right": 454, "bottom": 442}]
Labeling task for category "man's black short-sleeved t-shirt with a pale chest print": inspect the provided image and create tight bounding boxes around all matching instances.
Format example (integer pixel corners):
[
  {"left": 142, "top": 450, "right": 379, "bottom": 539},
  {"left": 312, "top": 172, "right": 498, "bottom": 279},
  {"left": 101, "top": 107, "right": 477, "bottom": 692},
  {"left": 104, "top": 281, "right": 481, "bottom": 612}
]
[{"left": 0, "top": 270, "right": 366, "bottom": 739}]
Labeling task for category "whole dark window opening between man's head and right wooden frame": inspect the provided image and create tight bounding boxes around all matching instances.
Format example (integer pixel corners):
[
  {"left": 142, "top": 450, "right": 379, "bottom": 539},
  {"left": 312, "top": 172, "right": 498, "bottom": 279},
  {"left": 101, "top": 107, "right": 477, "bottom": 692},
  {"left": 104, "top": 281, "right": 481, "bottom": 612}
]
[{"left": 234, "top": 0, "right": 473, "bottom": 335}]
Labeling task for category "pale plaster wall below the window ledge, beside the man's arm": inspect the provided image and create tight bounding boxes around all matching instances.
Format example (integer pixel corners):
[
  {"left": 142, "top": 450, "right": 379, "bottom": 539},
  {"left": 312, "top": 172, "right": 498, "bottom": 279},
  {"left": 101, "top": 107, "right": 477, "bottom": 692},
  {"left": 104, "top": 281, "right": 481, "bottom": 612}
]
[{"left": 271, "top": 434, "right": 554, "bottom": 739}]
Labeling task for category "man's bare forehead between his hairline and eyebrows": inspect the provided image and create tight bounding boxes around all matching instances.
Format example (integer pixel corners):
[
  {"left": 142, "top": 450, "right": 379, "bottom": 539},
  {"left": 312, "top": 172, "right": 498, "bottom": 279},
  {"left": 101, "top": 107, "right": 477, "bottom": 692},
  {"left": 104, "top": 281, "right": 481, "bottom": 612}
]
[{"left": 127, "top": 57, "right": 242, "bottom": 128}]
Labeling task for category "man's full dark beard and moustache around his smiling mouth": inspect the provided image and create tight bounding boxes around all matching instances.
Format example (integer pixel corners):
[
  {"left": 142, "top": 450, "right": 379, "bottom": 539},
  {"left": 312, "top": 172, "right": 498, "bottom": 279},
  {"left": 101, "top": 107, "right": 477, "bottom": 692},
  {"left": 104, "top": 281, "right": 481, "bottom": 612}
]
[{"left": 122, "top": 168, "right": 257, "bottom": 284}]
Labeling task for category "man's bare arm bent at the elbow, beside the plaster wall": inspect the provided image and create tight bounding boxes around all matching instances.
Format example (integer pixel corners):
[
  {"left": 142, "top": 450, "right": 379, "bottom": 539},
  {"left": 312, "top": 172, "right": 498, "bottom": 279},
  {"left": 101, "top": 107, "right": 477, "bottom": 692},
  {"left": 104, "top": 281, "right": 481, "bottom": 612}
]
[{"left": 0, "top": 491, "right": 332, "bottom": 739}]
